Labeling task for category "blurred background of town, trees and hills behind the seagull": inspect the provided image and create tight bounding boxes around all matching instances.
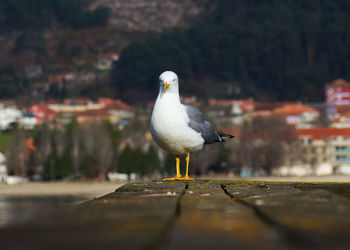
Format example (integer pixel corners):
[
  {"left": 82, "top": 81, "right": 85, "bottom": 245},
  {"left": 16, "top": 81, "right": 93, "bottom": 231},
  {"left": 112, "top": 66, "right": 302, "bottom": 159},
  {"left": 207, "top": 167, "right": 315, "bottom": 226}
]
[{"left": 0, "top": 0, "right": 350, "bottom": 227}]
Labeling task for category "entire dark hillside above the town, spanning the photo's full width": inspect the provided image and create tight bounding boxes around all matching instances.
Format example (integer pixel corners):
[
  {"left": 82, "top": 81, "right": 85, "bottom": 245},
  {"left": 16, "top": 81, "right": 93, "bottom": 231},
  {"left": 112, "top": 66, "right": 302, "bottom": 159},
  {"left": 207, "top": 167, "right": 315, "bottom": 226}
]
[{"left": 0, "top": 0, "right": 350, "bottom": 102}]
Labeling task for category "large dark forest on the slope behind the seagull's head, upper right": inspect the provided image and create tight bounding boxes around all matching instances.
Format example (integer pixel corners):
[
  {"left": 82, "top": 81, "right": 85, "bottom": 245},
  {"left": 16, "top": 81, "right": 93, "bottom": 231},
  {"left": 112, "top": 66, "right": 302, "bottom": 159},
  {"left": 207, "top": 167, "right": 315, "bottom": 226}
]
[{"left": 113, "top": 0, "right": 350, "bottom": 101}]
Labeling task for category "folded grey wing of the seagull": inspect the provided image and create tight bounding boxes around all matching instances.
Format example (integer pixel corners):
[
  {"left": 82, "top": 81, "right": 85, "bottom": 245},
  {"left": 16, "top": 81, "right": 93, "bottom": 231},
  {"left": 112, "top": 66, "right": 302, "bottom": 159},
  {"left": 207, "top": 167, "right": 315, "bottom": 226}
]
[{"left": 185, "top": 105, "right": 222, "bottom": 144}]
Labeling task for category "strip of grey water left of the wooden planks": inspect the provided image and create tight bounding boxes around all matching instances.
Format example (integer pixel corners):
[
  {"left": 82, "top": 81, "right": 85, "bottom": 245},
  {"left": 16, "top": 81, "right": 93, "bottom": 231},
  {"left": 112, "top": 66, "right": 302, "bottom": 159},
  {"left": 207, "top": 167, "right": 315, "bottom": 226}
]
[{"left": 0, "top": 196, "right": 88, "bottom": 228}]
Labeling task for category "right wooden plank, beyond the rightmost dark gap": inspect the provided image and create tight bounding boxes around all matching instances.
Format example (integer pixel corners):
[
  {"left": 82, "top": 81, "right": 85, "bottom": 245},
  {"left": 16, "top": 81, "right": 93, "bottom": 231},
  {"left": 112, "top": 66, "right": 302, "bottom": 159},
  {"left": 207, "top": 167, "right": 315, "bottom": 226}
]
[{"left": 225, "top": 184, "right": 350, "bottom": 249}]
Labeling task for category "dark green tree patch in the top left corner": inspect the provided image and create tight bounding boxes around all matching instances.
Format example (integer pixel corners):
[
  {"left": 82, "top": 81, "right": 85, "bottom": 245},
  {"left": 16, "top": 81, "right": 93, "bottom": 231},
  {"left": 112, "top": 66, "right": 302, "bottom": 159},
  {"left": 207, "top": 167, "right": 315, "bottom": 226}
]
[{"left": 0, "top": 0, "right": 109, "bottom": 34}]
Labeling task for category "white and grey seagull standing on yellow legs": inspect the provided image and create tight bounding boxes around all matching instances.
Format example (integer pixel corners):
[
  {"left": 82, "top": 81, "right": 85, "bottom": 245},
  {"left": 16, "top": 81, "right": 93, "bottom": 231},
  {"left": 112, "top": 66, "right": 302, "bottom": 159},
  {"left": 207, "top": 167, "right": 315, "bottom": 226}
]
[{"left": 150, "top": 71, "right": 234, "bottom": 181}]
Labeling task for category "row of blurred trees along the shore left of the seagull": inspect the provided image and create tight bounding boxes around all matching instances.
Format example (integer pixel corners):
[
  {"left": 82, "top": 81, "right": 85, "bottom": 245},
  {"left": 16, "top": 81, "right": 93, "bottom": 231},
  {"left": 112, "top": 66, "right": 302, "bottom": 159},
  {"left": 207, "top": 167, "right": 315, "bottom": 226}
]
[{"left": 5, "top": 120, "right": 120, "bottom": 180}]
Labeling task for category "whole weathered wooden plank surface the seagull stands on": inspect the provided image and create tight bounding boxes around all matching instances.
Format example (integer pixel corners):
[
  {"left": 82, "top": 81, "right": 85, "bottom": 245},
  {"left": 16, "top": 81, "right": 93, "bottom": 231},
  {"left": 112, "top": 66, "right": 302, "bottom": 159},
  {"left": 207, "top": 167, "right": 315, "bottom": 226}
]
[{"left": 0, "top": 180, "right": 350, "bottom": 250}]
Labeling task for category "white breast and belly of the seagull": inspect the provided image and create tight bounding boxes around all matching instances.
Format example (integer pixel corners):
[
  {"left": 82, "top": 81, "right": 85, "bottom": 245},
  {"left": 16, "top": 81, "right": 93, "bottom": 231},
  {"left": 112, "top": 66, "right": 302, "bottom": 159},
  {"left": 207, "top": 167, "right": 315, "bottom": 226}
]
[{"left": 151, "top": 95, "right": 204, "bottom": 155}]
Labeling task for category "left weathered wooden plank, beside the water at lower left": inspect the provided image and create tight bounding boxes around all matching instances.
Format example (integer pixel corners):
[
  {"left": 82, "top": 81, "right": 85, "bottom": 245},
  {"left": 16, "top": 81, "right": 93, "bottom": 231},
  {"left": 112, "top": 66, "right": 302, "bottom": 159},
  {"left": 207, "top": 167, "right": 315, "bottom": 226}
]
[{"left": 0, "top": 182, "right": 185, "bottom": 250}]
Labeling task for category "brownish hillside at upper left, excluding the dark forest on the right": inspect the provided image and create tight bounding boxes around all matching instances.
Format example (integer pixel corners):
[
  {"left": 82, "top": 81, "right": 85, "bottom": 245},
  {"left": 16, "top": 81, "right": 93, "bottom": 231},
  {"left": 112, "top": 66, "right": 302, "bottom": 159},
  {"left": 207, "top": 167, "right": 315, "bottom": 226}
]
[{"left": 0, "top": 0, "right": 211, "bottom": 99}]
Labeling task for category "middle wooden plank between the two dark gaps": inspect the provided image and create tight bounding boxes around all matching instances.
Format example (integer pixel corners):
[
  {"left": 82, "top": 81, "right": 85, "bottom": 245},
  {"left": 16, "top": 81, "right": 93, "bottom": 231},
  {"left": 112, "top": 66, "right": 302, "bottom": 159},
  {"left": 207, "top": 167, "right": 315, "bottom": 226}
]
[{"left": 166, "top": 181, "right": 289, "bottom": 249}]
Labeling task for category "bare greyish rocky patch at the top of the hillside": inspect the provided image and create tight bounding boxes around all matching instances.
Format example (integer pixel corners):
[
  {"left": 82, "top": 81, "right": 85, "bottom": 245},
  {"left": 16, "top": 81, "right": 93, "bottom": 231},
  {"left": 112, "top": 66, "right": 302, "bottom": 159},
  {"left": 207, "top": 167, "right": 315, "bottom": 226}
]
[{"left": 90, "top": 0, "right": 216, "bottom": 32}]
